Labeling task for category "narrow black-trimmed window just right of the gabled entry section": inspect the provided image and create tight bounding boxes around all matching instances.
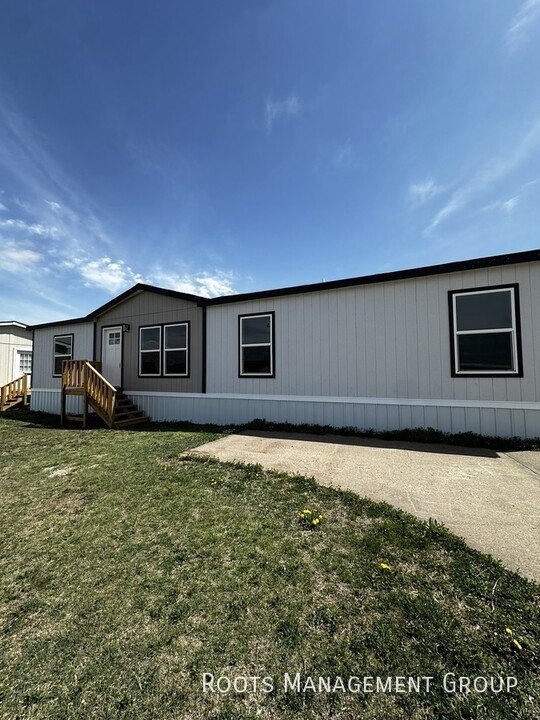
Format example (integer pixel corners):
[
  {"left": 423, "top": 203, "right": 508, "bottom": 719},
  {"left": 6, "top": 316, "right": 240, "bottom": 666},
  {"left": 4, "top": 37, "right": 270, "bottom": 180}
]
[{"left": 239, "top": 312, "right": 274, "bottom": 377}]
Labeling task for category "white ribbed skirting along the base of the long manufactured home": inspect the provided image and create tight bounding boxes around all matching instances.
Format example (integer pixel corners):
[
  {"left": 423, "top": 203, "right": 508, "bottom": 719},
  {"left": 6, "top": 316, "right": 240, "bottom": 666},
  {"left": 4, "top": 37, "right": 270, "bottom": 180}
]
[{"left": 31, "top": 388, "right": 540, "bottom": 438}]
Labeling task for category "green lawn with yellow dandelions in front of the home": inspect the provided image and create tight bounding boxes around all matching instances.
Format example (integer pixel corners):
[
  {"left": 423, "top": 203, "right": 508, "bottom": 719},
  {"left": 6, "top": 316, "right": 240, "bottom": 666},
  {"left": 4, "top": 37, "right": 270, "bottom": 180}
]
[{"left": 0, "top": 412, "right": 540, "bottom": 720}]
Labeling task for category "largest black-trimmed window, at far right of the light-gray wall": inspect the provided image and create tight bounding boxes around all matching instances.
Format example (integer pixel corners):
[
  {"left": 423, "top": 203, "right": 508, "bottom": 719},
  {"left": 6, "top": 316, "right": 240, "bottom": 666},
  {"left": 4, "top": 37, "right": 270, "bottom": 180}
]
[{"left": 450, "top": 285, "right": 522, "bottom": 377}]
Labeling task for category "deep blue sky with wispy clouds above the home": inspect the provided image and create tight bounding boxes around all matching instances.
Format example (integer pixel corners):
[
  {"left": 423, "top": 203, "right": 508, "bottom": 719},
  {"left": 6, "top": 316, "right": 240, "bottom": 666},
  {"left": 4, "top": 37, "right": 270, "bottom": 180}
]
[{"left": 0, "top": 0, "right": 540, "bottom": 323}]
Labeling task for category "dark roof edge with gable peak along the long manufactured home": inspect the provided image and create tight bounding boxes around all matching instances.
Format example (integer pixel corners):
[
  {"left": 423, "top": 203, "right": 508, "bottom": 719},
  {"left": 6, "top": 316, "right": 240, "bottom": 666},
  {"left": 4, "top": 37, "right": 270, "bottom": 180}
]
[{"left": 28, "top": 249, "right": 540, "bottom": 330}]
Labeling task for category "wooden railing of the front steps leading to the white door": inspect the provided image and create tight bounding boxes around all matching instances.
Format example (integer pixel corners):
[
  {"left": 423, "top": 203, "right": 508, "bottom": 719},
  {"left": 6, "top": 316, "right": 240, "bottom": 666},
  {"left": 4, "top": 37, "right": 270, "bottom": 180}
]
[{"left": 61, "top": 360, "right": 116, "bottom": 427}]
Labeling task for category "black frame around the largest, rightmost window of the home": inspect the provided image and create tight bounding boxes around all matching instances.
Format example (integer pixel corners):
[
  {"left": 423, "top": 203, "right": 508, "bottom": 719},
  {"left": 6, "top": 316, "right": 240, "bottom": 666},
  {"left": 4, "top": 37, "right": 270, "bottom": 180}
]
[{"left": 448, "top": 283, "right": 523, "bottom": 378}]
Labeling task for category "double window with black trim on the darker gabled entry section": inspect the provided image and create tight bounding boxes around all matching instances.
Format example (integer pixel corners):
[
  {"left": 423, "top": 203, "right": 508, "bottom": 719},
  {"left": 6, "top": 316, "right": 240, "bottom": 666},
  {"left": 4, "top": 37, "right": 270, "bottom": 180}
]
[{"left": 139, "top": 322, "right": 189, "bottom": 377}]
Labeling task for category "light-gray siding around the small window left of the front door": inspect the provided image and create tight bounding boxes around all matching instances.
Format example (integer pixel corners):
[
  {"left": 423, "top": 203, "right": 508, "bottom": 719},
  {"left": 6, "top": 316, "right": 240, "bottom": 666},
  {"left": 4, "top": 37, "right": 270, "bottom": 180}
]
[{"left": 32, "top": 323, "right": 94, "bottom": 389}]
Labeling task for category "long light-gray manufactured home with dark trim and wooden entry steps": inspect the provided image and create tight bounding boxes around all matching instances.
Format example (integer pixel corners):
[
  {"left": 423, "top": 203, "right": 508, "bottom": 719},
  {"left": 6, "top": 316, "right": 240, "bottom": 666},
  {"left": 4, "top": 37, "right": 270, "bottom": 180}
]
[{"left": 31, "top": 250, "right": 540, "bottom": 438}]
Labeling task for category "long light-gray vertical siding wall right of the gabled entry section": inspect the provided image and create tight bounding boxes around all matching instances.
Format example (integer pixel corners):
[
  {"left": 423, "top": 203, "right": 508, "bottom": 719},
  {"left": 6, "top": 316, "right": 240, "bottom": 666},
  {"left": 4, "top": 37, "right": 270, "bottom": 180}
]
[{"left": 207, "top": 263, "right": 540, "bottom": 402}]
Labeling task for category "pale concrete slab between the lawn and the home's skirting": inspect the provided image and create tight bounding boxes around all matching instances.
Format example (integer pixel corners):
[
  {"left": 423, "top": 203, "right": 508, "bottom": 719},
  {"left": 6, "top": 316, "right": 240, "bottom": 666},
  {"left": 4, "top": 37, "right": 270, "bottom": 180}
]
[{"left": 190, "top": 432, "right": 540, "bottom": 581}]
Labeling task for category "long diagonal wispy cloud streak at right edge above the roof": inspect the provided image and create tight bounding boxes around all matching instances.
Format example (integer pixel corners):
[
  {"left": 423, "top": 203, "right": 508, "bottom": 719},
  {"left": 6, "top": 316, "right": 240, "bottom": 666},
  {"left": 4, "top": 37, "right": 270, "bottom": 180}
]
[{"left": 424, "top": 121, "right": 540, "bottom": 234}]
